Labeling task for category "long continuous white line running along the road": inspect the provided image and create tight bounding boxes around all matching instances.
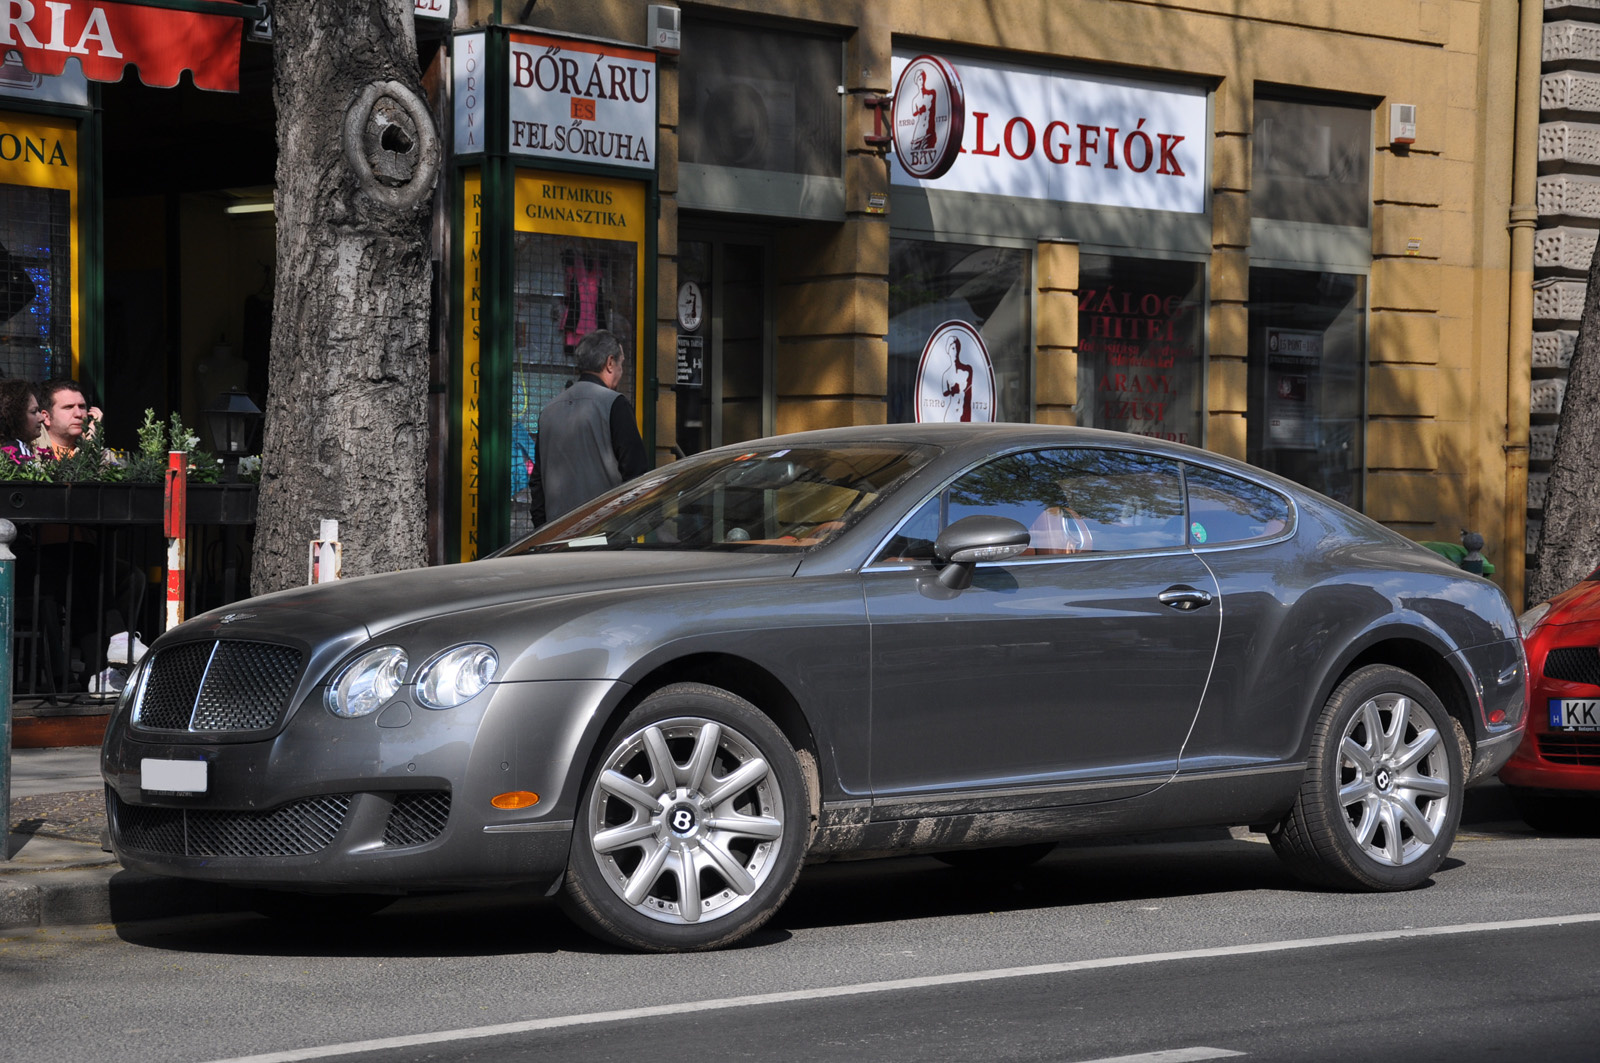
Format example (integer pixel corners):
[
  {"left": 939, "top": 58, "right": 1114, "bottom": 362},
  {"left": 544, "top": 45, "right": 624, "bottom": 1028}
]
[{"left": 213, "top": 913, "right": 1600, "bottom": 1063}]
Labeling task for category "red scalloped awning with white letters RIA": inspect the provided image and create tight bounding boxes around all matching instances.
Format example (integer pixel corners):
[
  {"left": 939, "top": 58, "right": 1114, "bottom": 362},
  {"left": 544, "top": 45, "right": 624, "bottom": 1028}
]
[{"left": 0, "top": 0, "right": 264, "bottom": 93}]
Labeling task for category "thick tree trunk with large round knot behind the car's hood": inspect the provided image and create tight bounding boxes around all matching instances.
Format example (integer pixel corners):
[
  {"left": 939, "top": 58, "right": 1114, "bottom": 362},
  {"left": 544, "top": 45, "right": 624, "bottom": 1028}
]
[{"left": 251, "top": 0, "right": 440, "bottom": 594}]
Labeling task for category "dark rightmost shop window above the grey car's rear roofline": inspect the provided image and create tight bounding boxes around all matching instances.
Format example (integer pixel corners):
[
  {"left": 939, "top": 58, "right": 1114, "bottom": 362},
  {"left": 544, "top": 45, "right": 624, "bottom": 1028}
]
[{"left": 1246, "top": 266, "right": 1366, "bottom": 509}]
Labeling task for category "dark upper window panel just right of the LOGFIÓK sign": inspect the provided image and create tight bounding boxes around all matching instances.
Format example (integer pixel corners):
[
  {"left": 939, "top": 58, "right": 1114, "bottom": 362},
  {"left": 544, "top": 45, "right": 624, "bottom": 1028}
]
[{"left": 1250, "top": 98, "right": 1373, "bottom": 227}]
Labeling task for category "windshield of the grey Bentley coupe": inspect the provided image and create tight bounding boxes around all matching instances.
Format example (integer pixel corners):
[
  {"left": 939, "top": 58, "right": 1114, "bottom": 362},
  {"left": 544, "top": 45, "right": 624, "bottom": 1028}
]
[{"left": 504, "top": 443, "right": 938, "bottom": 556}]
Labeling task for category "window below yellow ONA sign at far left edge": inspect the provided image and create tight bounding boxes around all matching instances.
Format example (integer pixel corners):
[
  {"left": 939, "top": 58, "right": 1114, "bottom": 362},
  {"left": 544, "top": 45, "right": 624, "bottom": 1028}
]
[{"left": 0, "top": 184, "right": 72, "bottom": 381}]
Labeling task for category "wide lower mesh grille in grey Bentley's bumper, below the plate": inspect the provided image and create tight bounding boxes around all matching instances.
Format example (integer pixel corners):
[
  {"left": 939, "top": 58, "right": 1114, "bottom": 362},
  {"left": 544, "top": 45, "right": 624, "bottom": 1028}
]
[{"left": 106, "top": 791, "right": 352, "bottom": 856}]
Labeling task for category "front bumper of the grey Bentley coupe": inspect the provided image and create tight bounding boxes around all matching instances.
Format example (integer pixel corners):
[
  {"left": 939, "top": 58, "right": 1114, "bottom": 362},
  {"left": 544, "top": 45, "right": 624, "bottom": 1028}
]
[{"left": 101, "top": 682, "right": 616, "bottom": 892}]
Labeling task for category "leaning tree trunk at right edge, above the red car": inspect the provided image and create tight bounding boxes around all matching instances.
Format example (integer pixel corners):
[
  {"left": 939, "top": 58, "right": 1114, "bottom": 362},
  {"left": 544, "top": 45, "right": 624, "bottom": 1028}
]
[{"left": 1528, "top": 250, "right": 1600, "bottom": 605}]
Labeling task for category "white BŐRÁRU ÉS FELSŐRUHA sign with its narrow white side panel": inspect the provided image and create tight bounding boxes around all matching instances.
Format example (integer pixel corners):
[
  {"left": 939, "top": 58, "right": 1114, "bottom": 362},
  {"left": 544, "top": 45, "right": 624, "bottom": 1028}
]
[{"left": 454, "top": 34, "right": 656, "bottom": 170}]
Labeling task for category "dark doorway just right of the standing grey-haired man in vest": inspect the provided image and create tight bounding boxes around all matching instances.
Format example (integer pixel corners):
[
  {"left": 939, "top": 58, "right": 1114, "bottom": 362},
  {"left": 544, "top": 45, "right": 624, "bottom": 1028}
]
[{"left": 672, "top": 229, "right": 776, "bottom": 455}]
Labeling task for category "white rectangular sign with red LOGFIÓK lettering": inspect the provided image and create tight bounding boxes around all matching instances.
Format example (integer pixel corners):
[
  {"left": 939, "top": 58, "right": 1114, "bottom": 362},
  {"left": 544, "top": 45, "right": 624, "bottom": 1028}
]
[{"left": 891, "top": 51, "right": 1208, "bottom": 215}]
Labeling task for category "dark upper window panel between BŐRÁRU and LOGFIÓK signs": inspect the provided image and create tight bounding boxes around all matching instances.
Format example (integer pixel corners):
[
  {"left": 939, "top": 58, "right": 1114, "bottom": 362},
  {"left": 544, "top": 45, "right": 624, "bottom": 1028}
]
[{"left": 678, "top": 21, "right": 843, "bottom": 178}]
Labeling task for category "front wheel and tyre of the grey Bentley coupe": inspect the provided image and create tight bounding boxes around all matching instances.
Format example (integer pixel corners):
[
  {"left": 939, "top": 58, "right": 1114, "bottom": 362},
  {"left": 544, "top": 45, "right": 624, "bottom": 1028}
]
[{"left": 563, "top": 684, "right": 811, "bottom": 953}]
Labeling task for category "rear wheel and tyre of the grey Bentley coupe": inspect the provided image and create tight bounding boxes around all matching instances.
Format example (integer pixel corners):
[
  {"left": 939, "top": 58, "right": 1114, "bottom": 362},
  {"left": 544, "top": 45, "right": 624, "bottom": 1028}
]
[{"left": 1267, "top": 664, "right": 1466, "bottom": 890}]
